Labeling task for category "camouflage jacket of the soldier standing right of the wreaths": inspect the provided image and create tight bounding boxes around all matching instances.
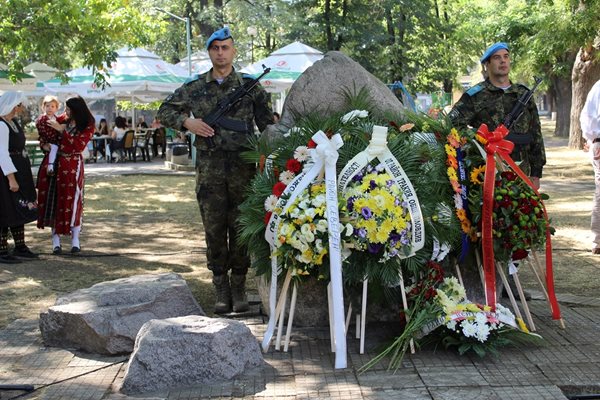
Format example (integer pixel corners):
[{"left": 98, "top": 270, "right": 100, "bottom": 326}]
[{"left": 449, "top": 80, "right": 546, "bottom": 178}]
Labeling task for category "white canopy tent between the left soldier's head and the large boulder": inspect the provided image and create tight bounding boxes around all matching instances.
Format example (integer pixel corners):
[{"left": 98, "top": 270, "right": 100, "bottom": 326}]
[{"left": 242, "top": 42, "right": 323, "bottom": 93}]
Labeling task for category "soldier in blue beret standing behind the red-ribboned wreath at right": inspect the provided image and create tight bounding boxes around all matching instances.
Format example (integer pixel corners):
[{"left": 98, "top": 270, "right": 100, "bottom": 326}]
[{"left": 449, "top": 43, "right": 546, "bottom": 189}]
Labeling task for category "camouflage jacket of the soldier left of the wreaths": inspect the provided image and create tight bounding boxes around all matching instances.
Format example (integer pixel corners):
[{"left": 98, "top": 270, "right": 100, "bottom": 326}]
[{"left": 157, "top": 69, "right": 273, "bottom": 151}]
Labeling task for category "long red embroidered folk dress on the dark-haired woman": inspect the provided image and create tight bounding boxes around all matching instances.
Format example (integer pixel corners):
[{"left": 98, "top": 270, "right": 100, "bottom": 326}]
[{"left": 38, "top": 114, "right": 94, "bottom": 235}]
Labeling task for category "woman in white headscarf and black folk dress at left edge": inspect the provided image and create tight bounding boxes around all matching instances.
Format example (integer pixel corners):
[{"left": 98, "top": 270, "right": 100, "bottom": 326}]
[{"left": 0, "top": 92, "right": 37, "bottom": 264}]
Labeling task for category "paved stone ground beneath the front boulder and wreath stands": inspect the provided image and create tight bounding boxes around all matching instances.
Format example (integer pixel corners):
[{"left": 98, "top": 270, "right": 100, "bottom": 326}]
[{"left": 0, "top": 293, "right": 600, "bottom": 400}]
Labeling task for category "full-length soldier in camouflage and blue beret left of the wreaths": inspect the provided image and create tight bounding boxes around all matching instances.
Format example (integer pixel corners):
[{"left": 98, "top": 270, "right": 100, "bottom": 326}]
[{"left": 158, "top": 28, "right": 273, "bottom": 314}]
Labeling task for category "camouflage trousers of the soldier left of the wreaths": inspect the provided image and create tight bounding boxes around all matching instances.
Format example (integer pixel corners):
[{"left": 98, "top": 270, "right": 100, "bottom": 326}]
[{"left": 196, "top": 151, "right": 256, "bottom": 276}]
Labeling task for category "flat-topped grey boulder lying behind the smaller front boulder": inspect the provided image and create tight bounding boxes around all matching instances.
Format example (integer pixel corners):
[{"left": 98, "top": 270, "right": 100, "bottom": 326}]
[{"left": 40, "top": 273, "right": 205, "bottom": 354}]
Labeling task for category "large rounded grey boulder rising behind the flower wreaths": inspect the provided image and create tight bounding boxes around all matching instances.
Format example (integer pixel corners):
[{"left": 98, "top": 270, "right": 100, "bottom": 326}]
[{"left": 266, "top": 51, "right": 404, "bottom": 140}]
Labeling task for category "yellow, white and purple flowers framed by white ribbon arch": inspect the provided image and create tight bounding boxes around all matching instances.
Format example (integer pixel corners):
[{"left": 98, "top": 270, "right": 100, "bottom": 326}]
[{"left": 342, "top": 164, "right": 411, "bottom": 262}]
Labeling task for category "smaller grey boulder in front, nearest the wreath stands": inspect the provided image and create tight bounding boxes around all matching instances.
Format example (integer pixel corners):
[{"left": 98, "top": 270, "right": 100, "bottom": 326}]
[{"left": 121, "top": 316, "right": 264, "bottom": 393}]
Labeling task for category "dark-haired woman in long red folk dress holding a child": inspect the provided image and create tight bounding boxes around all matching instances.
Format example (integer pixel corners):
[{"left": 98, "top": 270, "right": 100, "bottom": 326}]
[{"left": 38, "top": 96, "right": 95, "bottom": 254}]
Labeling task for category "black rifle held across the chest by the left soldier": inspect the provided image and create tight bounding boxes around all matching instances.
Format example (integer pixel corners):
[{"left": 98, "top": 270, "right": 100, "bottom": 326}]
[{"left": 202, "top": 64, "right": 271, "bottom": 149}]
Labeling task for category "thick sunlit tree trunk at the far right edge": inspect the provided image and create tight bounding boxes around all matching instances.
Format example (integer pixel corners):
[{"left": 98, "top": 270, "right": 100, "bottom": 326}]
[{"left": 569, "top": 45, "right": 600, "bottom": 149}]
